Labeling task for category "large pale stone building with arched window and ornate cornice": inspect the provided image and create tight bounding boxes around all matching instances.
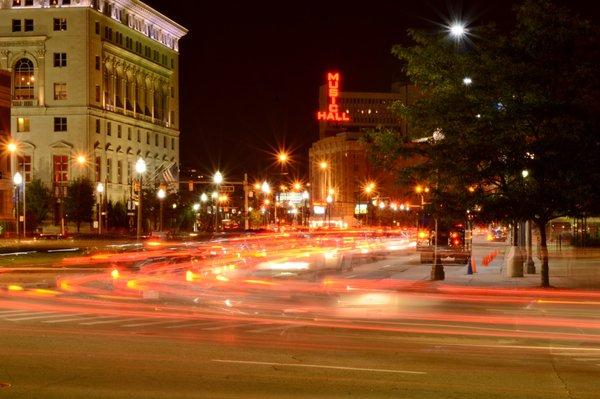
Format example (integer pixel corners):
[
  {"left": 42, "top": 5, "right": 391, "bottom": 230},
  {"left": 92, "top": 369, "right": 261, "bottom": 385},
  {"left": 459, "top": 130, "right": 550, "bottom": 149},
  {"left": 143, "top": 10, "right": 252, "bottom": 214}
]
[{"left": 0, "top": 0, "right": 187, "bottom": 227}]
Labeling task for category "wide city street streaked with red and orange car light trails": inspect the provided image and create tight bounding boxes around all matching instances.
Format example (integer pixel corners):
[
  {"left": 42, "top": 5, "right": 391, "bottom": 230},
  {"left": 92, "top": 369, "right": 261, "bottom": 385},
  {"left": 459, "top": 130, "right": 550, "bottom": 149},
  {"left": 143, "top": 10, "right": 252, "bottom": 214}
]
[{"left": 0, "top": 233, "right": 600, "bottom": 398}]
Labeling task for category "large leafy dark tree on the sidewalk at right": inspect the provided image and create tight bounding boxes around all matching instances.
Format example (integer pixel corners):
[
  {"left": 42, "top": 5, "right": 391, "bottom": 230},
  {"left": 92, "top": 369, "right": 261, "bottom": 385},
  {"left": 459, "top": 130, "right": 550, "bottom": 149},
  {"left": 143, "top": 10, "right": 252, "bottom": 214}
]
[{"left": 369, "top": 0, "right": 600, "bottom": 287}]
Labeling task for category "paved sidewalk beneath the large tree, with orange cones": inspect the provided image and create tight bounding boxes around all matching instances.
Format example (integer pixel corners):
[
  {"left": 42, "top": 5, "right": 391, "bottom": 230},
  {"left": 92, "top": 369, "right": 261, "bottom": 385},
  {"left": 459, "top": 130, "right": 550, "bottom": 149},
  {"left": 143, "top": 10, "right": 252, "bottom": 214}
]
[{"left": 391, "top": 243, "right": 600, "bottom": 290}]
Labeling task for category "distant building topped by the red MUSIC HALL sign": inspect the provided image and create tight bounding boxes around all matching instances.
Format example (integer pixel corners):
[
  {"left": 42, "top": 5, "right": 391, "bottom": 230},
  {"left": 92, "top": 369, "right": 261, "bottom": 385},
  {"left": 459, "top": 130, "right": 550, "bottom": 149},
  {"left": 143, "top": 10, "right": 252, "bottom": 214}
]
[{"left": 309, "top": 84, "right": 417, "bottom": 226}]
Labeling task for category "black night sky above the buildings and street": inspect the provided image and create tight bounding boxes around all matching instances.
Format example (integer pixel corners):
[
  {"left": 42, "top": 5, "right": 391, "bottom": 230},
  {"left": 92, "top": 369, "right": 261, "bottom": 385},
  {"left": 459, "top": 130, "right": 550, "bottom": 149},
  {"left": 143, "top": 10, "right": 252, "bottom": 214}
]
[{"left": 146, "top": 0, "right": 598, "bottom": 180}]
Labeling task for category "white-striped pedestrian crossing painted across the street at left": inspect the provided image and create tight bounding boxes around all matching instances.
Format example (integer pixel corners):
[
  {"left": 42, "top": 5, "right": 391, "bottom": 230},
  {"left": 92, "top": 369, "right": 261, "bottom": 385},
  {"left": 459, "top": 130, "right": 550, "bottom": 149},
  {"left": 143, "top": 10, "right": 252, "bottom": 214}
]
[{"left": 0, "top": 309, "right": 307, "bottom": 334}]
